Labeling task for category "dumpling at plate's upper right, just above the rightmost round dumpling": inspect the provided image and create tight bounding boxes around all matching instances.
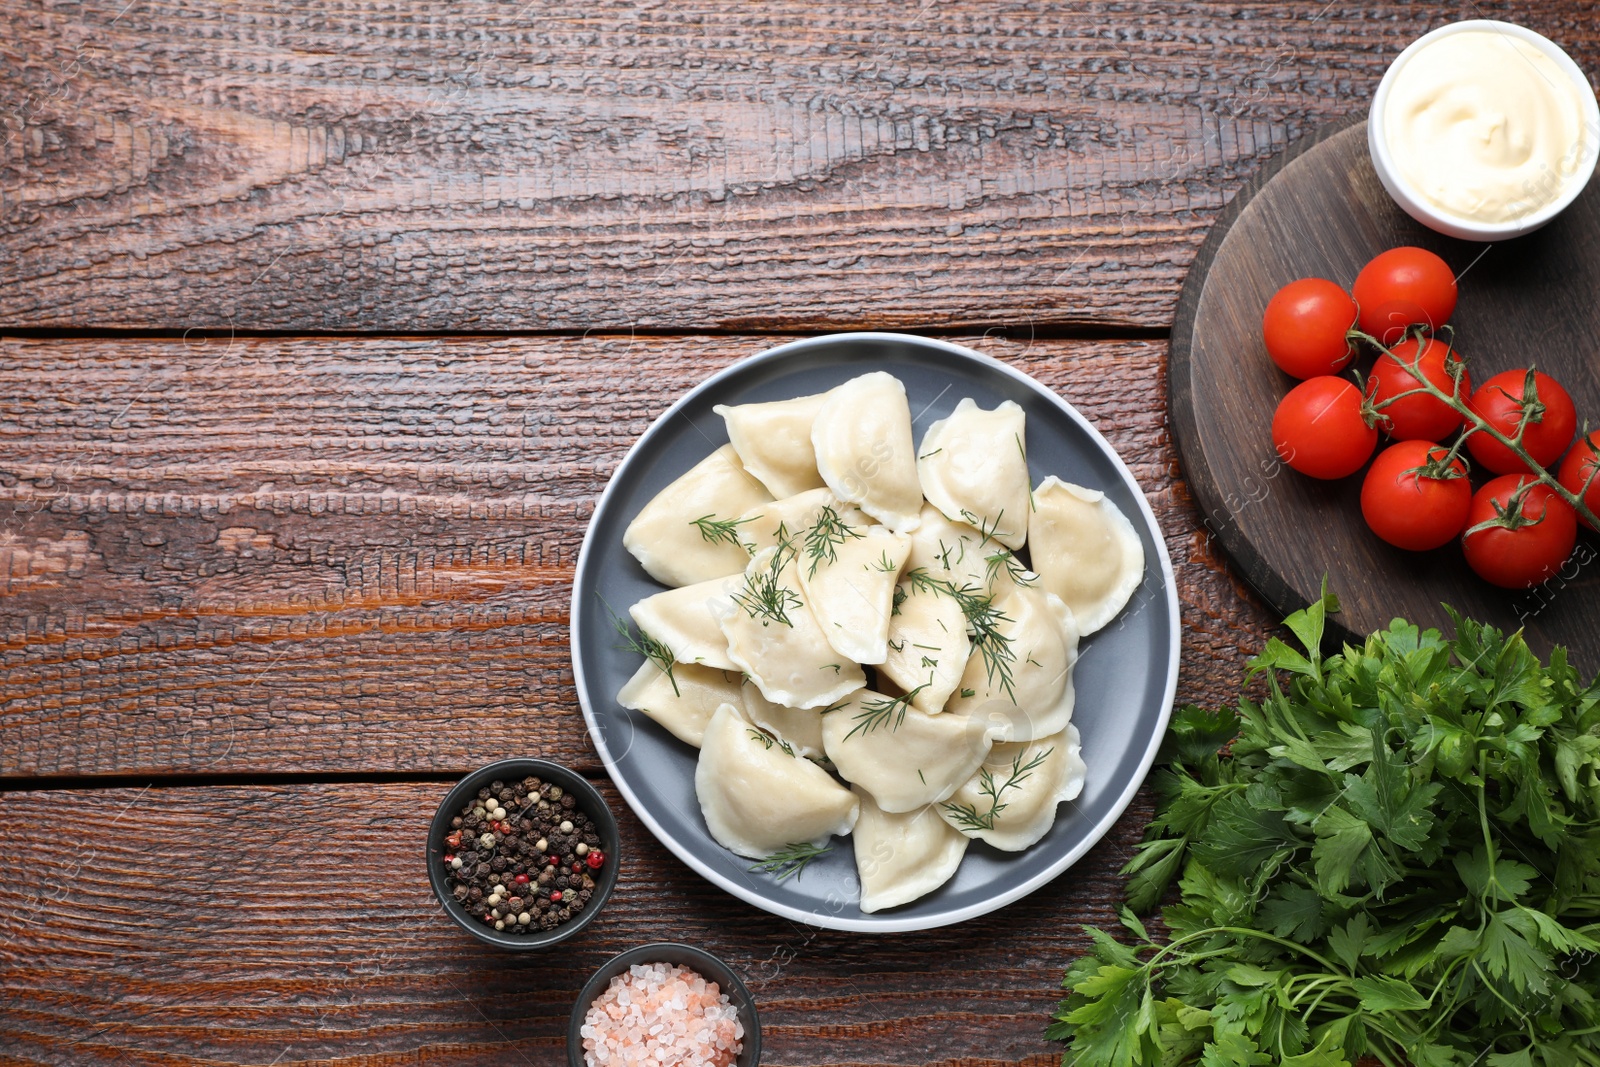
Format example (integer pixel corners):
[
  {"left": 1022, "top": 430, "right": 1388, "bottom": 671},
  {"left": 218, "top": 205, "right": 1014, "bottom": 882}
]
[{"left": 917, "top": 397, "right": 1032, "bottom": 549}]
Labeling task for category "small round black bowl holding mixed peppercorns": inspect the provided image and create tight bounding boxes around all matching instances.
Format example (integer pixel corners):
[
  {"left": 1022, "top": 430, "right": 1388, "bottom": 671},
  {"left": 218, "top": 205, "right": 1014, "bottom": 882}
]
[{"left": 427, "top": 760, "right": 621, "bottom": 950}]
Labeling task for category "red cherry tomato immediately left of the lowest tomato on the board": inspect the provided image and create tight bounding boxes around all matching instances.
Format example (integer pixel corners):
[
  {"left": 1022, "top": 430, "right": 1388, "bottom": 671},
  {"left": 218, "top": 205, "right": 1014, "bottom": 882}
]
[{"left": 1362, "top": 442, "right": 1472, "bottom": 552}]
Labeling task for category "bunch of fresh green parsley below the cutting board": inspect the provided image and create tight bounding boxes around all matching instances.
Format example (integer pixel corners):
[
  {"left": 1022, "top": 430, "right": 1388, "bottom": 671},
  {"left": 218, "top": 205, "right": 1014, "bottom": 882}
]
[{"left": 1048, "top": 595, "right": 1600, "bottom": 1067}]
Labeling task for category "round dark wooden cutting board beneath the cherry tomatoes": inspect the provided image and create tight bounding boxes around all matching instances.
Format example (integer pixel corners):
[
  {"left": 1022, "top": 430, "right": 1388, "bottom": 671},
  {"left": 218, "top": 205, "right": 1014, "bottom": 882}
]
[{"left": 1171, "top": 122, "right": 1600, "bottom": 668}]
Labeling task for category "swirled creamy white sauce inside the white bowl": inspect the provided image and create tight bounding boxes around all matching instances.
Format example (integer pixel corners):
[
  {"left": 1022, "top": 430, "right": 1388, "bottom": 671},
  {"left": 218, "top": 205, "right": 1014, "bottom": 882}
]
[{"left": 1381, "top": 29, "right": 1600, "bottom": 224}]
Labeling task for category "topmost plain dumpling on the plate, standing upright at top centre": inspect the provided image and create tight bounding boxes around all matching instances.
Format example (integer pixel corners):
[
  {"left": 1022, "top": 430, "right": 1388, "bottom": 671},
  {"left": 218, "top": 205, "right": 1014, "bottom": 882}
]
[{"left": 811, "top": 371, "right": 922, "bottom": 533}]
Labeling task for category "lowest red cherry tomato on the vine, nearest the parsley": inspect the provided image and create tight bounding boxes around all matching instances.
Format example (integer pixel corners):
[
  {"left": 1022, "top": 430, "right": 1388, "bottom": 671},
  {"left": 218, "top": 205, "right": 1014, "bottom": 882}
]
[{"left": 1461, "top": 474, "right": 1578, "bottom": 589}]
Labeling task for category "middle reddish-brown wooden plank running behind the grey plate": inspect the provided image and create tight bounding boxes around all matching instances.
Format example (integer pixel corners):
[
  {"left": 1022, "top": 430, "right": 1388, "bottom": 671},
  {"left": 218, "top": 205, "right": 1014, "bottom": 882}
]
[{"left": 0, "top": 336, "right": 1269, "bottom": 776}]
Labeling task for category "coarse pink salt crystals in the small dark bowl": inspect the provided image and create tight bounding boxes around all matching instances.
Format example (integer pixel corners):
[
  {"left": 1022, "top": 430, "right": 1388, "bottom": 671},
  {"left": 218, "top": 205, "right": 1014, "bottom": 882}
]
[{"left": 581, "top": 963, "right": 744, "bottom": 1067}]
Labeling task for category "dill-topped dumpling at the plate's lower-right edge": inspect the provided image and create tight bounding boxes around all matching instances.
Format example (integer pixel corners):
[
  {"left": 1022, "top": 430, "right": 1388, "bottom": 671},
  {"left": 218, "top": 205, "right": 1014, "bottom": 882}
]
[{"left": 939, "top": 726, "right": 1088, "bottom": 853}]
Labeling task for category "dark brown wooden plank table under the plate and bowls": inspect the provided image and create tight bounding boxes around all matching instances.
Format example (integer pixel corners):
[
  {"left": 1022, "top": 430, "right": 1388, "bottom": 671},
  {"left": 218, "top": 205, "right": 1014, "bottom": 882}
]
[{"left": 0, "top": 0, "right": 1600, "bottom": 1067}]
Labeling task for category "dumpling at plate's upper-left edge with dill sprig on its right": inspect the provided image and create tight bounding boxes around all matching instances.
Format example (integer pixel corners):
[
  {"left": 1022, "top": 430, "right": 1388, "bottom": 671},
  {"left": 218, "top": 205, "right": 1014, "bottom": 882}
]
[{"left": 622, "top": 445, "right": 773, "bottom": 585}]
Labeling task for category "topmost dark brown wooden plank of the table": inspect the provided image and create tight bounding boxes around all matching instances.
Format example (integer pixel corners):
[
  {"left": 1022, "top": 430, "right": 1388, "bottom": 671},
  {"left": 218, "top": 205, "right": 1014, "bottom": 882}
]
[{"left": 0, "top": 0, "right": 1600, "bottom": 330}]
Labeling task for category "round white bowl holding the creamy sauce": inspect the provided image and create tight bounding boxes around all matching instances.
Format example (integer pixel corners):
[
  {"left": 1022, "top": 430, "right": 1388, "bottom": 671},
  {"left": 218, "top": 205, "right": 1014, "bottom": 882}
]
[{"left": 1366, "top": 19, "right": 1600, "bottom": 242}]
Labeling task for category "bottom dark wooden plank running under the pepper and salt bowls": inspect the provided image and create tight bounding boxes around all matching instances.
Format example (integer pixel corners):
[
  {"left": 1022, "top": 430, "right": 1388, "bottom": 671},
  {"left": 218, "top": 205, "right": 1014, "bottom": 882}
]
[{"left": 0, "top": 780, "right": 1149, "bottom": 1067}]
